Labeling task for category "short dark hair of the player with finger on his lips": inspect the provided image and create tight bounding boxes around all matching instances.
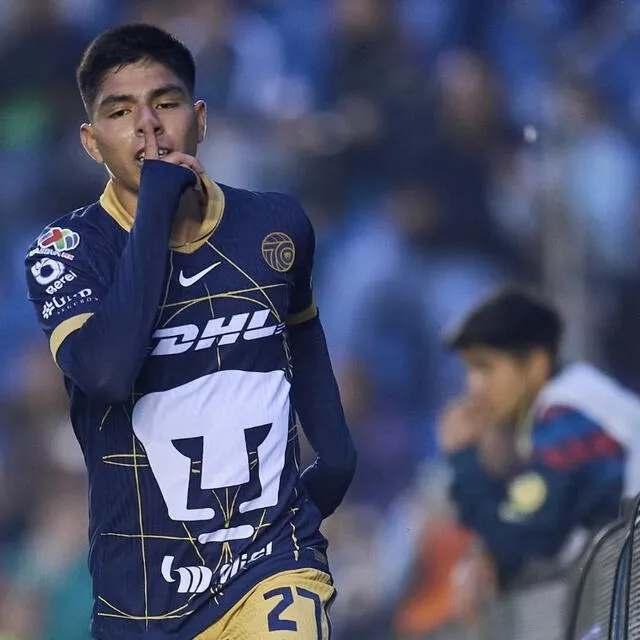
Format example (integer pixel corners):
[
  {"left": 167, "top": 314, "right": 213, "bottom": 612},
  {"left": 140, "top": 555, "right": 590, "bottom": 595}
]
[{"left": 76, "top": 24, "right": 196, "bottom": 117}]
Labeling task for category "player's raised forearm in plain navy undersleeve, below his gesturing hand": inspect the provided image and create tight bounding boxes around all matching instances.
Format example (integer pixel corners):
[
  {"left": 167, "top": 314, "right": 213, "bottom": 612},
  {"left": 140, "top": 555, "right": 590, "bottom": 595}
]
[{"left": 56, "top": 160, "right": 196, "bottom": 402}]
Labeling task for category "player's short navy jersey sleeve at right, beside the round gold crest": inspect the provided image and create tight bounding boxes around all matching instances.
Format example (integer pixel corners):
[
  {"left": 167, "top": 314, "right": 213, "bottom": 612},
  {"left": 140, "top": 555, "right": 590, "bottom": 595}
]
[{"left": 287, "top": 205, "right": 318, "bottom": 325}]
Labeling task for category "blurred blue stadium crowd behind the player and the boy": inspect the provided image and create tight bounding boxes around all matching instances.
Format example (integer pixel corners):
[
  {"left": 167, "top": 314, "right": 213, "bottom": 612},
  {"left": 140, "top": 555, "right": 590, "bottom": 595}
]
[{"left": 0, "top": 0, "right": 640, "bottom": 640}]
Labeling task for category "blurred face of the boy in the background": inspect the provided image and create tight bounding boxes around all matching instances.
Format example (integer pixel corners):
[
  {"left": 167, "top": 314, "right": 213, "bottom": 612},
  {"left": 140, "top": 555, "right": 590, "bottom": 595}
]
[{"left": 460, "top": 346, "right": 538, "bottom": 424}]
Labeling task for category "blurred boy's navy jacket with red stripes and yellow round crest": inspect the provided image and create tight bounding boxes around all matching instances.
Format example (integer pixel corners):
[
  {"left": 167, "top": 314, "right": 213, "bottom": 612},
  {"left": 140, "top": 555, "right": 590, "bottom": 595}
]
[{"left": 450, "top": 411, "right": 624, "bottom": 585}]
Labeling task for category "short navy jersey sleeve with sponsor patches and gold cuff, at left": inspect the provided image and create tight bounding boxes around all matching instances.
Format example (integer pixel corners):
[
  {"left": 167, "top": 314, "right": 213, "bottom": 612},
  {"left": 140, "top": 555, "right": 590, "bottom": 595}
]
[{"left": 25, "top": 223, "right": 106, "bottom": 359}]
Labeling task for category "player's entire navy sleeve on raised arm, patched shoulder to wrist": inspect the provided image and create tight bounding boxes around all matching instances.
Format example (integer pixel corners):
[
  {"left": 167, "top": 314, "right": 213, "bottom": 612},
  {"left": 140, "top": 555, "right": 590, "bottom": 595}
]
[{"left": 27, "top": 160, "right": 196, "bottom": 404}]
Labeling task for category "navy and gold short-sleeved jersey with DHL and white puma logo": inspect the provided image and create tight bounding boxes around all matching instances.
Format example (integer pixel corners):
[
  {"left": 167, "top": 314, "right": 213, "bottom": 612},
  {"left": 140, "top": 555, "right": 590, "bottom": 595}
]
[{"left": 22, "top": 178, "right": 338, "bottom": 638}]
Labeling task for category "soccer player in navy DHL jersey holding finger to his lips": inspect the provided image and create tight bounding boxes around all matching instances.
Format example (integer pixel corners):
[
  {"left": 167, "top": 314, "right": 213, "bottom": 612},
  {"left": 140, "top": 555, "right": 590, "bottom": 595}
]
[{"left": 26, "top": 25, "right": 356, "bottom": 640}]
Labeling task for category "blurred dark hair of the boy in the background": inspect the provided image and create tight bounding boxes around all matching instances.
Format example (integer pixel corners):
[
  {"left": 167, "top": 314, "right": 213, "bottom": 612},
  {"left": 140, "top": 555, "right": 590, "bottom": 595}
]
[{"left": 445, "top": 287, "right": 564, "bottom": 360}]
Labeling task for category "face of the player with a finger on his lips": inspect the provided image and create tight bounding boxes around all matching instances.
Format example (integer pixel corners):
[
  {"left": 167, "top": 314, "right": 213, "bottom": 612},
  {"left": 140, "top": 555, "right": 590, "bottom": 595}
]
[{"left": 81, "top": 61, "right": 206, "bottom": 193}]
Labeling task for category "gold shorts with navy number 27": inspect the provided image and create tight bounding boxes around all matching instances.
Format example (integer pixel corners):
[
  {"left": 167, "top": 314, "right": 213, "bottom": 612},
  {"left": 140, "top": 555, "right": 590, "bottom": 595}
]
[{"left": 195, "top": 568, "right": 335, "bottom": 640}]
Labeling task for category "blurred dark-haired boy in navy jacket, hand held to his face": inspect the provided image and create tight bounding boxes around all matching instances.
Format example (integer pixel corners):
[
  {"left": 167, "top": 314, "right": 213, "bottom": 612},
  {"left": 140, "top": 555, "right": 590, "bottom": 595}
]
[{"left": 440, "top": 289, "right": 640, "bottom": 586}]
